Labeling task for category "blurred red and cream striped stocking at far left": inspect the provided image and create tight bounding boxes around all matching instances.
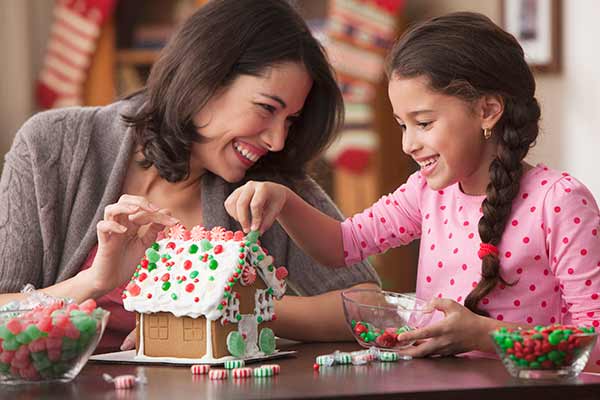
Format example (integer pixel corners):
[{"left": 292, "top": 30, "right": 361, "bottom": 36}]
[{"left": 36, "top": 0, "right": 116, "bottom": 108}]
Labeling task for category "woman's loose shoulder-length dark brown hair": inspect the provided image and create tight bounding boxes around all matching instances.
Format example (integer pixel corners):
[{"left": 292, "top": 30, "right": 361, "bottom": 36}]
[{"left": 123, "top": 0, "right": 343, "bottom": 182}]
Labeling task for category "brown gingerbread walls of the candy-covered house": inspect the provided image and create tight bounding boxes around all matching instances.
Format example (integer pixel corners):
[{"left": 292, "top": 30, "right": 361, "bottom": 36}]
[{"left": 136, "top": 279, "right": 269, "bottom": 358}]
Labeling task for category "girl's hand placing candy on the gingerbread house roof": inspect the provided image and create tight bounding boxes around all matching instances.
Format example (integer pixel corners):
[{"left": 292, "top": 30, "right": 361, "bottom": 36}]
[{"left": 225, "top": 181, "right": 289, "bottom": 234}]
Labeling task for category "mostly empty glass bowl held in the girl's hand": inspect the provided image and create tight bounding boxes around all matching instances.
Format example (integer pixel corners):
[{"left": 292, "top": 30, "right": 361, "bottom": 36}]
[{"left": 342, "top": 289, "right": 433, "bottom": 351}]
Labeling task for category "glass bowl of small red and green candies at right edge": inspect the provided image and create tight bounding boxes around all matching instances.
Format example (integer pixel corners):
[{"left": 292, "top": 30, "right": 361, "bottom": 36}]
[{"left": 490, "top": 325, "right": 598, "bottom": 379}]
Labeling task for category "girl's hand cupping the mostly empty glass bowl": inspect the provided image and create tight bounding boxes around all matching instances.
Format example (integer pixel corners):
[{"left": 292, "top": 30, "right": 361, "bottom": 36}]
[{"left": 397, "top": 298, "right": 493, "bottom": 357}]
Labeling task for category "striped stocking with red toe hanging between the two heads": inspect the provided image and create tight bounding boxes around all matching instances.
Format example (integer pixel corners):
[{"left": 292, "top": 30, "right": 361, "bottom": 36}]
[{"left": 325, "top": 0, "right": 403, "bottom": 174}]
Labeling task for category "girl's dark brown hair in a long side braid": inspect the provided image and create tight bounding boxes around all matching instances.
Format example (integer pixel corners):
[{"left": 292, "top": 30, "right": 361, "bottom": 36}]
[{"left": 387, "top": 12, "right": 540, "bottom": 316}]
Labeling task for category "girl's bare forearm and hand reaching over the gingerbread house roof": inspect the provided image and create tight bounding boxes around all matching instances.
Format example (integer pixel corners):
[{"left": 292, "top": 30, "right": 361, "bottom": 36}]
[{"left": 225, "top": 181, "right": 345, "bottom": 266}]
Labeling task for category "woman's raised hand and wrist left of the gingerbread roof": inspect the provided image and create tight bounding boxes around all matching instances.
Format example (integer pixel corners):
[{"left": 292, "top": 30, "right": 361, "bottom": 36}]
[{"left": 89, "top": 194, "right": 179, "bottom": 292}]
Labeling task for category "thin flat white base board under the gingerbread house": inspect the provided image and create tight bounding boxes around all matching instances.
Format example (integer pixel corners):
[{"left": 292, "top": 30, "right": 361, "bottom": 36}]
[{"left": 90, "top": 350, "right": 297, "bottom": 366}]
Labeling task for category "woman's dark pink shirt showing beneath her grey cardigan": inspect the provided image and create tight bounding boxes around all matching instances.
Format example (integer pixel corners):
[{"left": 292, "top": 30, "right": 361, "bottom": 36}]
[{"left": 81, "top": 245, "right": 135, "bottom": 353}]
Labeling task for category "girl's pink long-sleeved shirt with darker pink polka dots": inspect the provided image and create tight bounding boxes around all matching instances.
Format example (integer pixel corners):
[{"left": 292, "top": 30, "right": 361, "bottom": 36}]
[{"left": 342, "top": 165, "right": 600, "bottom": 365}]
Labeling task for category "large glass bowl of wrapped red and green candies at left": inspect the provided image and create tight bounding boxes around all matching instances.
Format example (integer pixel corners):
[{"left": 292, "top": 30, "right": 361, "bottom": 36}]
[{"left": 0, "top": 299, "right": 110, "bottom": 384}]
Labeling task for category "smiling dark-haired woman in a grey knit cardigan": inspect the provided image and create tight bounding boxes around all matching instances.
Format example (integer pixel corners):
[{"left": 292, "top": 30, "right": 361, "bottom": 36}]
[{"left": 0, "top": 0, "right": 378, "bottom": 351}]
